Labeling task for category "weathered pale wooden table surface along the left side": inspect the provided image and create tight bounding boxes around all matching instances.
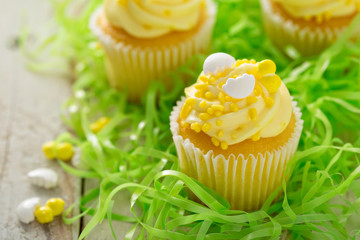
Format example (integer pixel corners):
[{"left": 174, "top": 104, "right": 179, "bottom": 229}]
[{"left": 0, "top": 0, "right": 131, "bottom": 240}]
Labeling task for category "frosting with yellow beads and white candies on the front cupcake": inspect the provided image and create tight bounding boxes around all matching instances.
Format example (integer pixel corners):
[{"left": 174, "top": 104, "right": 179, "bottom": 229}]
[{"left": 179, "top": 53, "right": 293, "bottom": 150}]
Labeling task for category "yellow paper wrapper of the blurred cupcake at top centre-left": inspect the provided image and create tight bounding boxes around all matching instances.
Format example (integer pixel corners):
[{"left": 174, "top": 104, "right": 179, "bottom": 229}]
[{"left": 89, "top": 1, "right": 216, "bottom": 101}]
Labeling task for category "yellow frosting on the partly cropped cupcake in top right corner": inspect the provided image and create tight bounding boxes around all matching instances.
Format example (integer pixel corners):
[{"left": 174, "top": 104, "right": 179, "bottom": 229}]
[{"left": 273, "top": 0, "right": 360, "bottom": 22}]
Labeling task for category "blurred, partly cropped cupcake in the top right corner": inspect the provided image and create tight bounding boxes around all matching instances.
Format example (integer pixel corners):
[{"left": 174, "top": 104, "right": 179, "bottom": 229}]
[{"left": 261, "top": 0, "right": 360, "bottom": 56}]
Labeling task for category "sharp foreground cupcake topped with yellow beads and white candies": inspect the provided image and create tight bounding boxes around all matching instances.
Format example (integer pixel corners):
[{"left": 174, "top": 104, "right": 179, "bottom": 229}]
[{"left": 170, "top": 53, "right": 303, "bottom": 211}]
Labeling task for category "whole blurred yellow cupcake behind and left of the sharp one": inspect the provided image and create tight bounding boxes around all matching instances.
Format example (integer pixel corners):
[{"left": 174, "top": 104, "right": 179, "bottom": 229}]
[{"left": 90, "top": 0, "right": 216, "bottom": 101}]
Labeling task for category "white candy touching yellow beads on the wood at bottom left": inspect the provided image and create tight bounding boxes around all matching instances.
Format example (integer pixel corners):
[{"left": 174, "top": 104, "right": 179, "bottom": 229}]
[{"left": 16, "top": 197, "right": 41, "bottom": 223}]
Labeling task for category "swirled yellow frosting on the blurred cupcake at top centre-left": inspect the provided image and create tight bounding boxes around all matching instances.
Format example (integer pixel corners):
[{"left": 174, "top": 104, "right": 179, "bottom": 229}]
[{"left": 104, "top": 0, "right": 204, "bottom": 38}]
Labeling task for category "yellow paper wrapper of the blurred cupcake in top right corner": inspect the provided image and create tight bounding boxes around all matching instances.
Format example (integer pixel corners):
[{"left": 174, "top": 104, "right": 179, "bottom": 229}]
[{"left": 261, "top": 0, "right": 346, "bottom": 56}]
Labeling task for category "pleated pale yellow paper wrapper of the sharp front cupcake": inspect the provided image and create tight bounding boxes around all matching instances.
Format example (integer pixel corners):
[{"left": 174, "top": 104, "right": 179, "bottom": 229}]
[{"left": 170, "top": 98, "right": 303, "bottom": 211}]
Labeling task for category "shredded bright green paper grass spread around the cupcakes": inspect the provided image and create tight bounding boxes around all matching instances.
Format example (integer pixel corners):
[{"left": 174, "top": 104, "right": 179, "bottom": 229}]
[{"left": 24, "top": 0, "right": 360, "bottom": 240}]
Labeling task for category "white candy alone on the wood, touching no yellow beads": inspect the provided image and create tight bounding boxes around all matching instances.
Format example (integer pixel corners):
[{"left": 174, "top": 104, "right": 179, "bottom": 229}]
[{"left": 28, "top": 168, "right": 58, "bottom": 189}]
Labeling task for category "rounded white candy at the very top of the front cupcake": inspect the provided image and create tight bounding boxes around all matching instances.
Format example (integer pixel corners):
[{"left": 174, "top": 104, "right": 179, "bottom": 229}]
[{"left": 203, "top": 52, "right": 236, "bottom": 74}]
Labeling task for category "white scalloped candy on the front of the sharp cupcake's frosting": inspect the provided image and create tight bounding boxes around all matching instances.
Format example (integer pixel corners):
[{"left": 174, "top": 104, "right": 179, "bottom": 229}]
[{"left": 223, "top": 73, "right": 255, "bottom": 99}]
